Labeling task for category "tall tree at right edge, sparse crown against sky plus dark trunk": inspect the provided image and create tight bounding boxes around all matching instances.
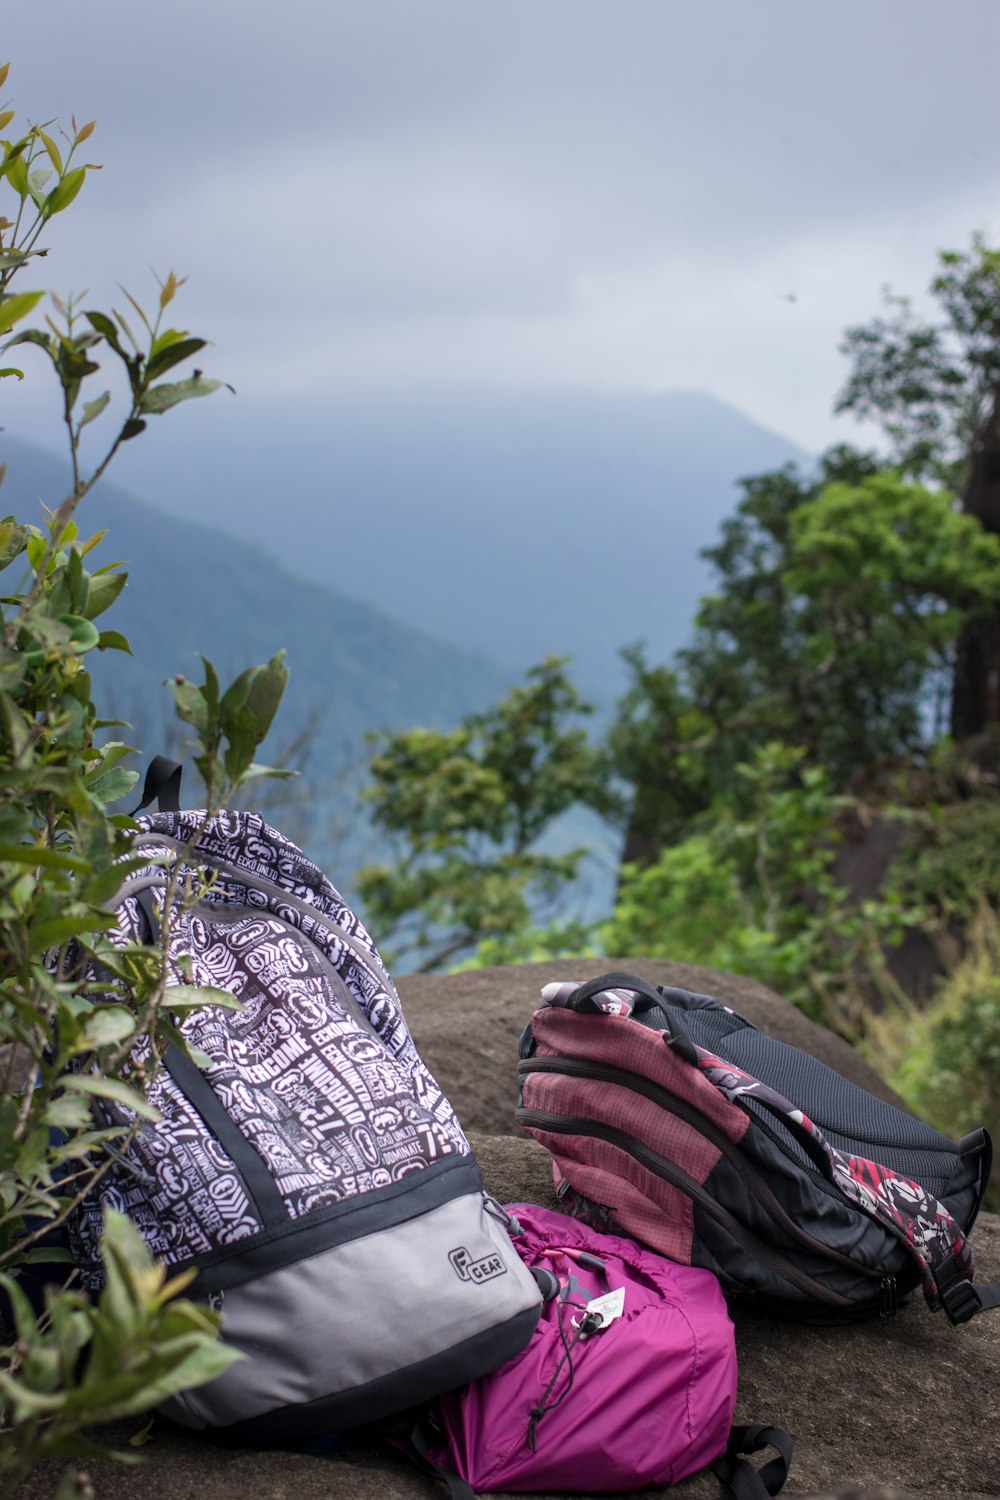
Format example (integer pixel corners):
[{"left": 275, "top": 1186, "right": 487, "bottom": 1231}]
[{"left": 837, "top": 234, "right": 1000, "bottom": 738}]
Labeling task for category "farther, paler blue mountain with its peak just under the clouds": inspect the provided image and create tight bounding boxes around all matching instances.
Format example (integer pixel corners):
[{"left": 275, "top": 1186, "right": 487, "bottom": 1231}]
[{"left": 107, "top": 389, "right": 813, "bottom": 707}]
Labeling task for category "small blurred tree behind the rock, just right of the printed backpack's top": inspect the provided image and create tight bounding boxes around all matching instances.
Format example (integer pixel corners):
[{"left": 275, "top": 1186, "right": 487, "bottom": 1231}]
[{"left": 357, "top": 657, "right": 607, "bottom": 971}]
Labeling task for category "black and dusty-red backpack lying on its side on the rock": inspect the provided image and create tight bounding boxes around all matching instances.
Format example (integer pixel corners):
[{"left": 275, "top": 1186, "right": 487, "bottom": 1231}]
[{"left": 517, "top": 974, "right": 1000, "bottom": 1323}]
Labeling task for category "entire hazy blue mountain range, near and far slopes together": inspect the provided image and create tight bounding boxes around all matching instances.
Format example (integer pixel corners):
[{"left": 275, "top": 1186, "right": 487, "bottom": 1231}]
[{"left": 0, "top": 392, "right": 811, "bottom": 915}]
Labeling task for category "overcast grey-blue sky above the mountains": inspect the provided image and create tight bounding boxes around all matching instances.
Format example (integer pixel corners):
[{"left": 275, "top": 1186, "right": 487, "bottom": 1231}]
[{"left": 0, "top": 0, "right": 1000, "bottom": 449}]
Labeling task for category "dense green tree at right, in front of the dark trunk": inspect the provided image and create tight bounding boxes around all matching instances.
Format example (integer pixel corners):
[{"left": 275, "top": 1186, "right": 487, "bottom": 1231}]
[{"left": 609, "top": 449, "right": 1000, "bottom": 861}]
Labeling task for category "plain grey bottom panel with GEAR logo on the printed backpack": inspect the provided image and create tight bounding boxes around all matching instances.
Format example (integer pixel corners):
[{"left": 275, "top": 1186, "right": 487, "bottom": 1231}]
[{"left": 160, "top": 1193, "right": 540, "bottom": 1442}]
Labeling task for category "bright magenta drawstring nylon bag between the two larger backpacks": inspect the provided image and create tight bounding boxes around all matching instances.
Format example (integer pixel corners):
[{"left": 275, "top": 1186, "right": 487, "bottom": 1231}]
[{"left": 411, "top": 1203, "right": 790, "bottom": 1500}]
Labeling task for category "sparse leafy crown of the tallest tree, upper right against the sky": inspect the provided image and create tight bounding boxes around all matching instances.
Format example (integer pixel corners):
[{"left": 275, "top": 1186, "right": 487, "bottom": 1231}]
[{"left": 837, "top": 234, "right": 1000, "bottom": 492}]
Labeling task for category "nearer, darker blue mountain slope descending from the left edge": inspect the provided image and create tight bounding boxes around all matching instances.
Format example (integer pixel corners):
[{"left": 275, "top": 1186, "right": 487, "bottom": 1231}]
[{"left": 0, "top": 438, "right": 516, "bottom": 852}]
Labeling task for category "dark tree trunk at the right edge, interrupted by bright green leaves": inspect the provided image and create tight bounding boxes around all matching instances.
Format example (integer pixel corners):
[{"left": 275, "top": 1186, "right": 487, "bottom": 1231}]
[{"left": 951, "top": 386, "right": 1000, "bottom": 740}]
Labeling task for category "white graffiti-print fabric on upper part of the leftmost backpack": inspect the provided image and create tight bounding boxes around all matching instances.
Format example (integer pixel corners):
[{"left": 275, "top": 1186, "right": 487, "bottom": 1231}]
[{"left": 72, "top": 813, "right": 469, "bottom": 1287}]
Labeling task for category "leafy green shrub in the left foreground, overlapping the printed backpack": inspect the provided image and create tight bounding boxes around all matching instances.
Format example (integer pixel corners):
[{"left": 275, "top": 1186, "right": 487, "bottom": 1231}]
[{"left": 0, "top": 68, "right": 286, "bottom": 1484}]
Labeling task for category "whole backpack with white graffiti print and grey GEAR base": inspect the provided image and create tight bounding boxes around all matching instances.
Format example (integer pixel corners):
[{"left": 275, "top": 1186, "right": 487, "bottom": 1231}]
[{"left": 70, "top": 780, "right": 541, "bottom": 1442}]
